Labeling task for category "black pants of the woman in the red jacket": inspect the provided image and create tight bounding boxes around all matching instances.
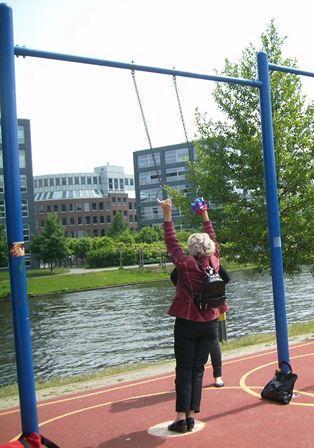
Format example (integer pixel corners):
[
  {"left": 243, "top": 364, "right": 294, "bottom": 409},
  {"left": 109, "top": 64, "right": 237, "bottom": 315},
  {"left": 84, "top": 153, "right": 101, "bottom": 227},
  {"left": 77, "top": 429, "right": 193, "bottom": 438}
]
[{"left": 174, "top": 318, "right": 221, "bottom": 412}]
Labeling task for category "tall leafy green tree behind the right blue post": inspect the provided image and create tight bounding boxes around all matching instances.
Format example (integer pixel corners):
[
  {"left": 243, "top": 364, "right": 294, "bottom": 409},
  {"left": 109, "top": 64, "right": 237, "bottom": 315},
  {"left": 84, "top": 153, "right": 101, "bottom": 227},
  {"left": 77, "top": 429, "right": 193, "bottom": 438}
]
[{"left": 181, "top": 21, "right": 314, "bottom": 271}]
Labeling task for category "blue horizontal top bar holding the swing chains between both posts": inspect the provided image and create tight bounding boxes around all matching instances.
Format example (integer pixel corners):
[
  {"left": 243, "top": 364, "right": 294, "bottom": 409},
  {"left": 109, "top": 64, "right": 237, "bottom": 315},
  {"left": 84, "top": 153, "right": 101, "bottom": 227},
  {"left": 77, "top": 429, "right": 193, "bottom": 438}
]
[{"left": 14, "top": 47, "right": 261, "bottom": 87}]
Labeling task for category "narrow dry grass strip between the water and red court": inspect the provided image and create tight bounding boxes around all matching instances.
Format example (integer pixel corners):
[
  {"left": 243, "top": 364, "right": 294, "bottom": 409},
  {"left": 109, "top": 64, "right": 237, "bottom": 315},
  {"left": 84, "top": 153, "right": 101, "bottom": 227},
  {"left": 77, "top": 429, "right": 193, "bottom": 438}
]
[{"left": 0, "top": 320, "right": 314, "bottom": 399}]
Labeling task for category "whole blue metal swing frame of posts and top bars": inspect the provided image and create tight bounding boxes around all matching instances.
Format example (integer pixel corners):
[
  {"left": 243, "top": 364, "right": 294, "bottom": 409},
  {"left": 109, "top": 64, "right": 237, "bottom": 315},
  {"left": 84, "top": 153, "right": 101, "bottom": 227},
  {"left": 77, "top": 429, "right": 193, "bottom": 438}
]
[{"left": 0, "top": 3, "right": 314, "bottom": 432}]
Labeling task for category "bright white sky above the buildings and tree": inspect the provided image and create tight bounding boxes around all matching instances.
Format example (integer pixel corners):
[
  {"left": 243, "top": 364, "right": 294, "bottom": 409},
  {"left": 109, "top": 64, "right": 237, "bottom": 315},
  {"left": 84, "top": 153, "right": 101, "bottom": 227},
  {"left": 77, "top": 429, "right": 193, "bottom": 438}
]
[{"left": 6, "top": 0, "right": 314, "bottom": 175}]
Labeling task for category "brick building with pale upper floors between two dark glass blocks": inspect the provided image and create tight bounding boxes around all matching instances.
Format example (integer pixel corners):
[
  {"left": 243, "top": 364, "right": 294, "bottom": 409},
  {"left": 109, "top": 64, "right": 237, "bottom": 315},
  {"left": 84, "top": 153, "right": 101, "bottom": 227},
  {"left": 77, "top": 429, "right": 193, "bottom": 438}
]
[{"left": 34, "top": 164, "right": 137, "bottom": 234}]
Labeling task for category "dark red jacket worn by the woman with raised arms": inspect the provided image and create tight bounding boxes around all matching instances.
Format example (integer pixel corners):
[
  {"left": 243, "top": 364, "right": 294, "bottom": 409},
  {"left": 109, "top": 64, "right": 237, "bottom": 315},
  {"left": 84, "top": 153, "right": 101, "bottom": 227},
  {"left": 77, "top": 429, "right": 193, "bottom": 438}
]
[{"left": 164, "top": 221, "right": 228, "bottom": 322}]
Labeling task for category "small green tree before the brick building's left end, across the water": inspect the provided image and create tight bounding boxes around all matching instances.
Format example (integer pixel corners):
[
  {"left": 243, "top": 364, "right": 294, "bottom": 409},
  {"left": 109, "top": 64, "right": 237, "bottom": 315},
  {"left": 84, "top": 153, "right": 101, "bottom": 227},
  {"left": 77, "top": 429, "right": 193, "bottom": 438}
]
[{"left": 31, "top": 213, "right": 67, "bottom": 271}]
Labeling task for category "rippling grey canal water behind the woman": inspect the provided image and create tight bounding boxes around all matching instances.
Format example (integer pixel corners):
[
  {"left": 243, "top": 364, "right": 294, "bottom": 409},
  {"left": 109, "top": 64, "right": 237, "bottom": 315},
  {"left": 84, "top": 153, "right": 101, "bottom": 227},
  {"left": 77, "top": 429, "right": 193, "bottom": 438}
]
[{"left": 0, "top": 271, "right": 314, "bottom": 386}]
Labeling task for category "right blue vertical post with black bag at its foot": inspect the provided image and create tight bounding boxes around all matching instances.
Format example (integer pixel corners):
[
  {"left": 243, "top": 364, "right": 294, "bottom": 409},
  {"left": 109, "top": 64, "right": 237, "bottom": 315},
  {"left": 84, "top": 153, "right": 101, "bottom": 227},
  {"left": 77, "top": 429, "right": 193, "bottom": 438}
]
[{"left": 257, "top": 52, "right": 289, "bottom": 372}]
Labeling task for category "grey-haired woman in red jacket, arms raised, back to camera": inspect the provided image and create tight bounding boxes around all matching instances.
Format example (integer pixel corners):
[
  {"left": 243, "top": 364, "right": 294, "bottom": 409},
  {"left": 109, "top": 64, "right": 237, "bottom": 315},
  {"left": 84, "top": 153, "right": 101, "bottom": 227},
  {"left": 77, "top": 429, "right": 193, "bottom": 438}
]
[{"left": 158, "top": 199, "right": 228, "bottom": 433}]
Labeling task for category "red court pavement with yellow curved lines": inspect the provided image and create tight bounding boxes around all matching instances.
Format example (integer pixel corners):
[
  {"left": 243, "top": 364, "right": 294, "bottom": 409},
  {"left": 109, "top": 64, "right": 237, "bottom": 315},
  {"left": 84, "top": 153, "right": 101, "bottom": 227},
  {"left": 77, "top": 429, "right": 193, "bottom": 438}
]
[{"left": 0, "top": 337, "right": 314, "bottom": 448}]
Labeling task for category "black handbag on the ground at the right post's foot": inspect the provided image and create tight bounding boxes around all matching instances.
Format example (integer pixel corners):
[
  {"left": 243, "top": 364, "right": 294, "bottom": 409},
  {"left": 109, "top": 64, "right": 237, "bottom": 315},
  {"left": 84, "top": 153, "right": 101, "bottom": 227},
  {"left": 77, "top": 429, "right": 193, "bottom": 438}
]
[{"left": 261, "top": 361, "right": 298, "bottom": 404}]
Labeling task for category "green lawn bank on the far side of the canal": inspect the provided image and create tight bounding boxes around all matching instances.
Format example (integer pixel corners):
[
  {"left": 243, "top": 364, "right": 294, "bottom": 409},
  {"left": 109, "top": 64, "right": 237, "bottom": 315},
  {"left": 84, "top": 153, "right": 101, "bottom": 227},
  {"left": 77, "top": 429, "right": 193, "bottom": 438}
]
[{"left": 0, "top": 265, "right": 251, "bottom": 299}]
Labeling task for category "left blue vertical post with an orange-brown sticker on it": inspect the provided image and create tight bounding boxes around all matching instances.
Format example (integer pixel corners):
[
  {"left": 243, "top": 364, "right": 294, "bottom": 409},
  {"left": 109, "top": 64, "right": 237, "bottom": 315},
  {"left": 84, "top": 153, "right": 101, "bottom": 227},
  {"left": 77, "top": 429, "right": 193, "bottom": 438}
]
[{"left": 0, "top": 3, "right": 38, "bottom": 432}]
